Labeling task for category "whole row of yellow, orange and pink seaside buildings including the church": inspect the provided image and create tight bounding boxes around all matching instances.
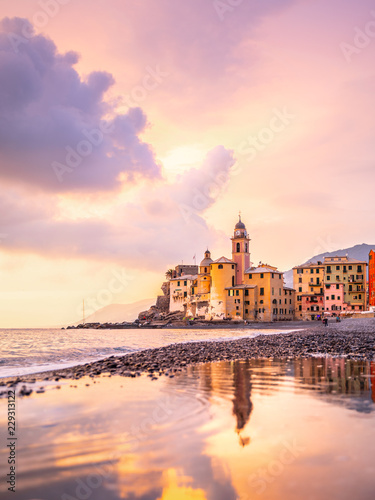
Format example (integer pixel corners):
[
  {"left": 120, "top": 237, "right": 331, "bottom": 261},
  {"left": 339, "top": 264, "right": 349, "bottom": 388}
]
[{"left": 139, "top": 215, "right": 375, "bottom": 322}]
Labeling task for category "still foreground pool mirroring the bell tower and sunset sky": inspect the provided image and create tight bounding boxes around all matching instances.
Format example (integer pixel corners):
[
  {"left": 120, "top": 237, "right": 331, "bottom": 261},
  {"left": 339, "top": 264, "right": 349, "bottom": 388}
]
[{"left": 0, "top": 358, "right": 375, "bottom": 500}]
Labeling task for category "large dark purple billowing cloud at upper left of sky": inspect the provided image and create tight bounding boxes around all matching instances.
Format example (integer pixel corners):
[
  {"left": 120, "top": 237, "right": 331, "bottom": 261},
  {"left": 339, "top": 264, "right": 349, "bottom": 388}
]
[{"left": 0, "top": 18, "right": 160, "bottom": 192}]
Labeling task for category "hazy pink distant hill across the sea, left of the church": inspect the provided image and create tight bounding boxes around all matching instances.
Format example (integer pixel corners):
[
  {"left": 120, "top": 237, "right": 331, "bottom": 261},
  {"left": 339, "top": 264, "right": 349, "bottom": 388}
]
[{"left": 78, "top": 299, "right": 156, "bottom": 323}]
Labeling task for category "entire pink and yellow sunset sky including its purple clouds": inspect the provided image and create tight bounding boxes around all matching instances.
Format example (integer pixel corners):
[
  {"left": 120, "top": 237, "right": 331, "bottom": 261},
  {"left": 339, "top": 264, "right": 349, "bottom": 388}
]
[{"left": 0, "top": 0, "right": 375, "bottom": 328}]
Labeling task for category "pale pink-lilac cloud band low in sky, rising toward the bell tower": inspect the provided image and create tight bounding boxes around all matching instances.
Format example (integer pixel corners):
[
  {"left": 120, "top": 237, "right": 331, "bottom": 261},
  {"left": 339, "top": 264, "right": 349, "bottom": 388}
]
[{"left": 0, "top": 146, "right": 235, "bottom": 270}]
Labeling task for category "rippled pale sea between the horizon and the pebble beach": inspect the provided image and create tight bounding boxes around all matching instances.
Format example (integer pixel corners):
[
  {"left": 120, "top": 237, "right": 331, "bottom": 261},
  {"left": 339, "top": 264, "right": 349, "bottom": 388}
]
[{"left": 0, "top": 328, "right": 296, "bottom": 377}]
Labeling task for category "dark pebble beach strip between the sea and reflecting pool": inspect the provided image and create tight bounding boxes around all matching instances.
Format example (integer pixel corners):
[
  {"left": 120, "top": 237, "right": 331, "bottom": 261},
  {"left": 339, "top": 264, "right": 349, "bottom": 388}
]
[{"left": 0, "top": 319, "right": 375, "bottom": 396}]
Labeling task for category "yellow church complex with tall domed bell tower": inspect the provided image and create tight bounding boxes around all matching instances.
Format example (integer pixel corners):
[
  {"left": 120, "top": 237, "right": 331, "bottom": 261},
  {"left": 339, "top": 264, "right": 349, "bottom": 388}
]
[{"left": 168, "top": 216, "right": 295, "bottom": 321}]
